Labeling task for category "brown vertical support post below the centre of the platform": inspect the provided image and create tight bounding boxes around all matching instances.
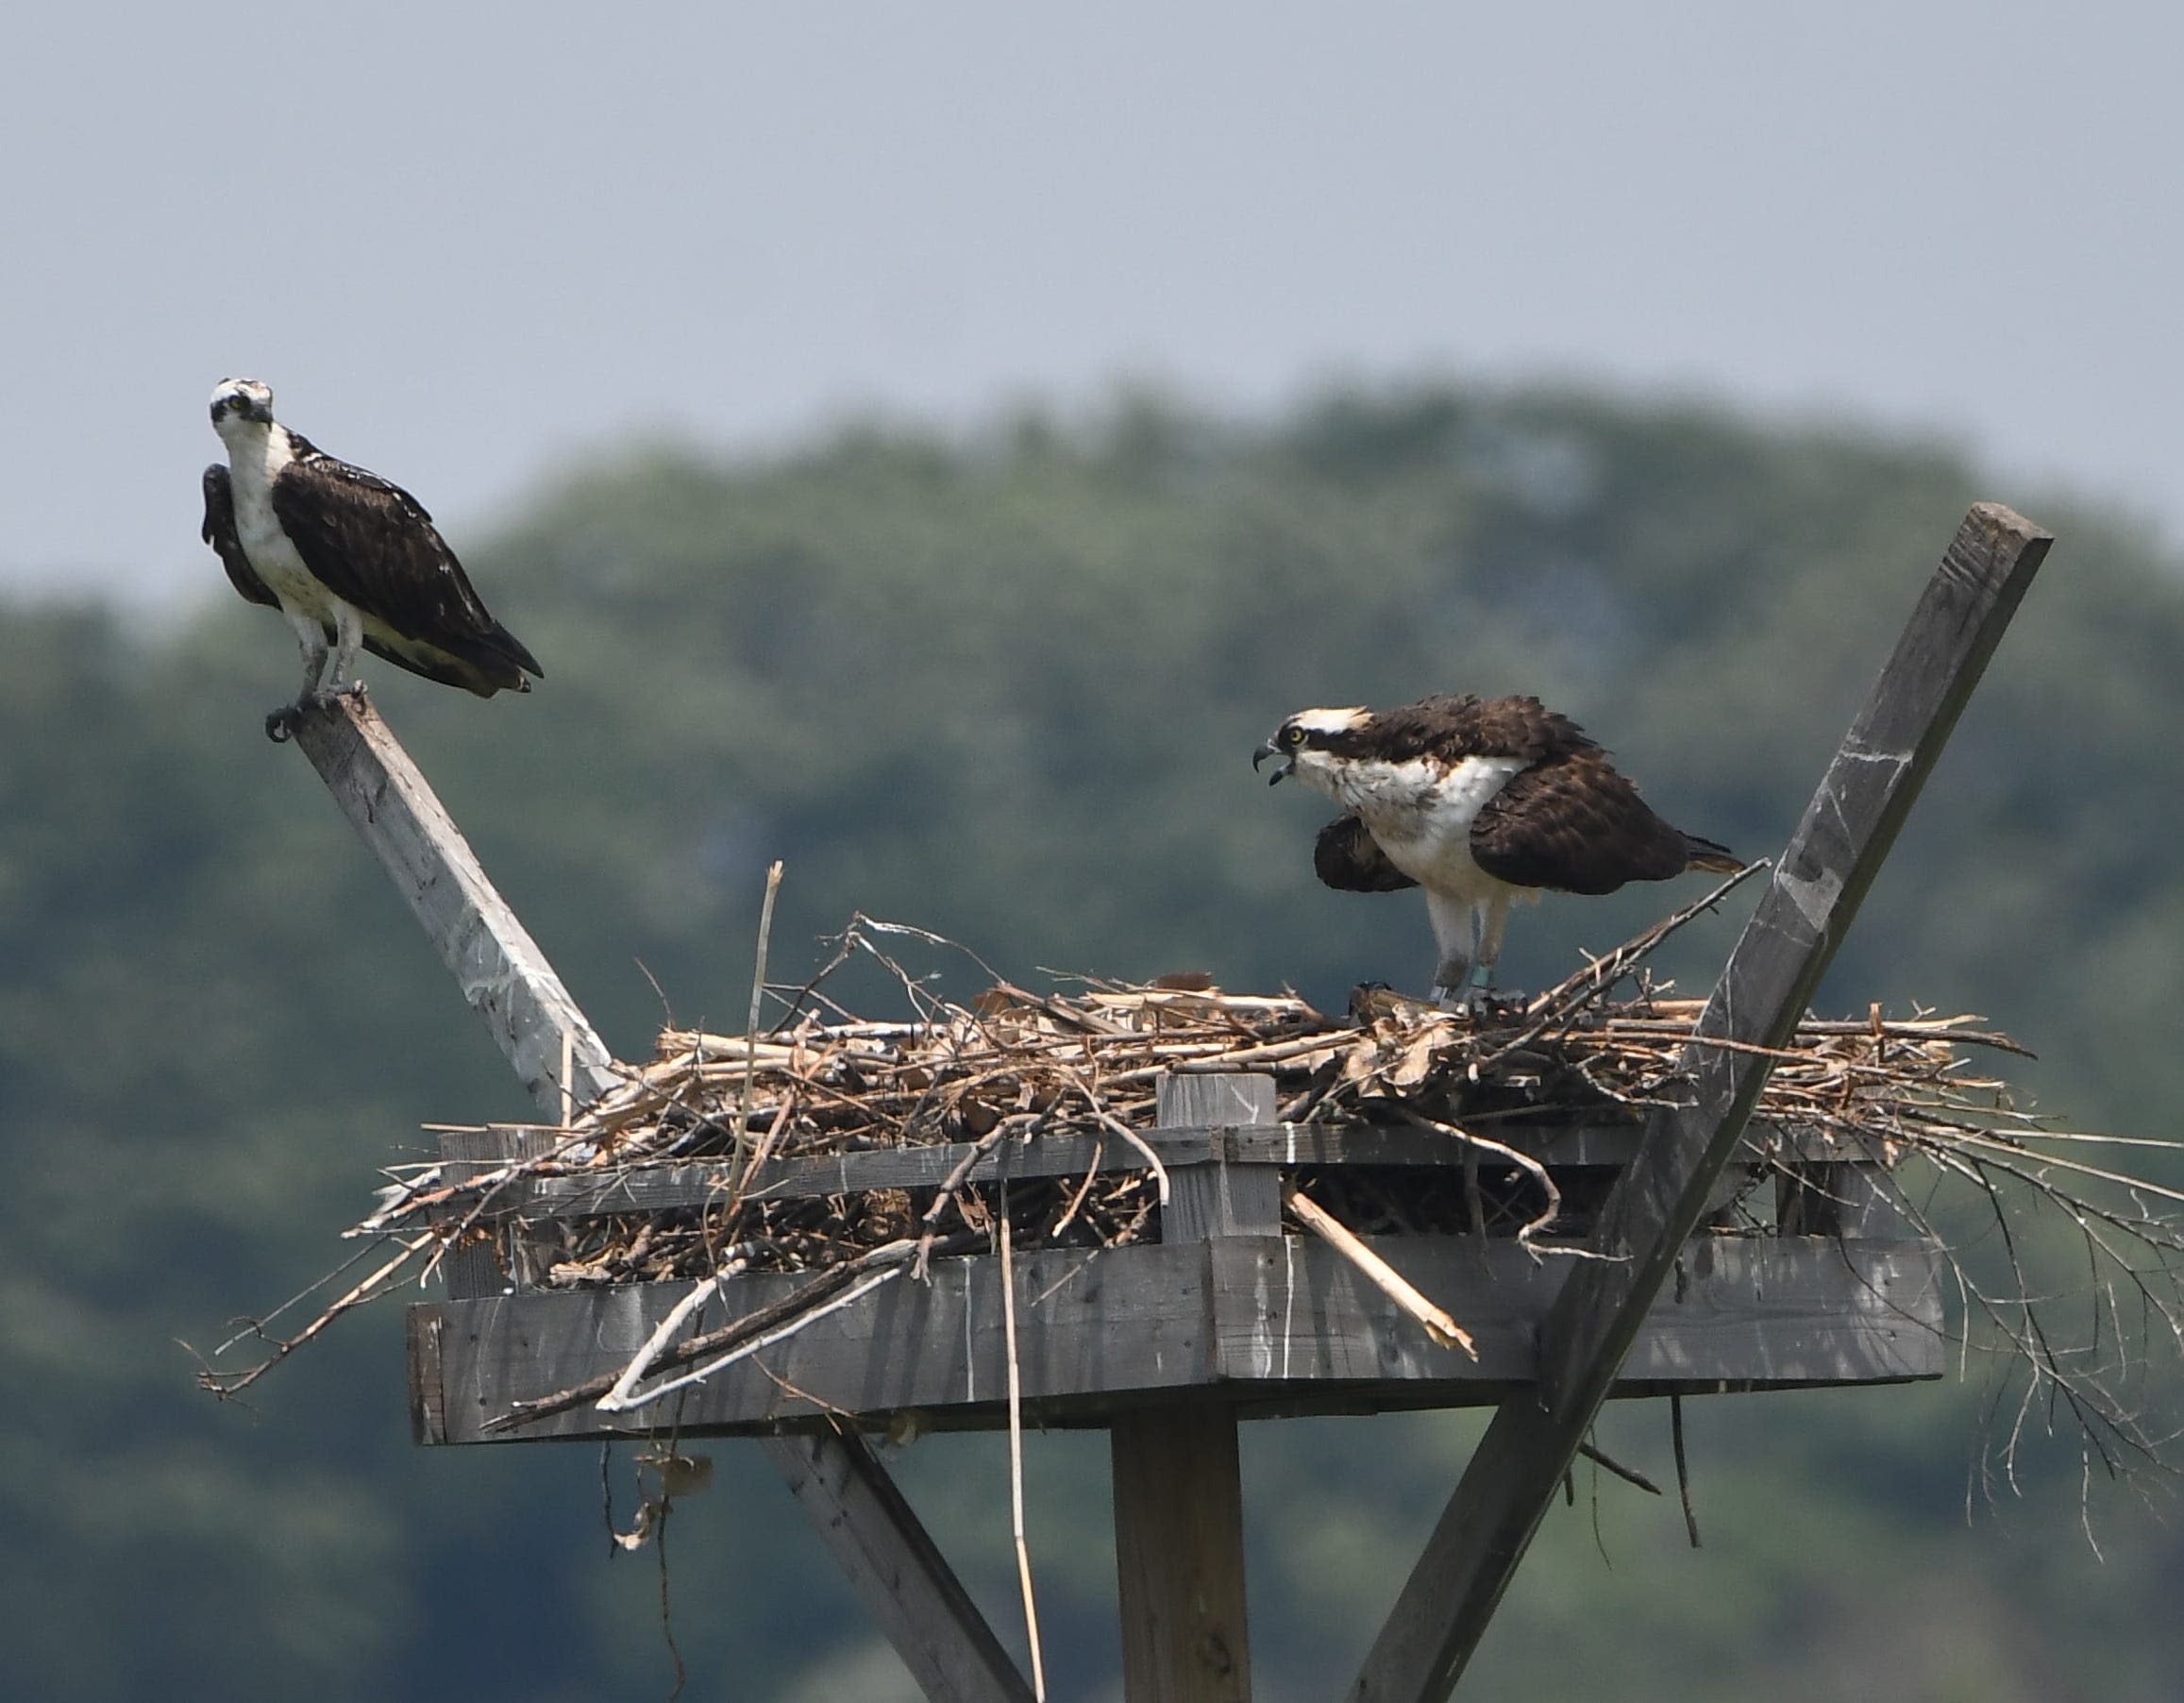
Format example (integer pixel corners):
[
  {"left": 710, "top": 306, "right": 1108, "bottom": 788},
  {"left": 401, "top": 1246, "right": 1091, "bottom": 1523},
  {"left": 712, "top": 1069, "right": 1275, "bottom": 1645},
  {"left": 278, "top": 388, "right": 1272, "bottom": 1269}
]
[{"left": 1110, "top": 1400, "right": 1252, "bottom": 1703}]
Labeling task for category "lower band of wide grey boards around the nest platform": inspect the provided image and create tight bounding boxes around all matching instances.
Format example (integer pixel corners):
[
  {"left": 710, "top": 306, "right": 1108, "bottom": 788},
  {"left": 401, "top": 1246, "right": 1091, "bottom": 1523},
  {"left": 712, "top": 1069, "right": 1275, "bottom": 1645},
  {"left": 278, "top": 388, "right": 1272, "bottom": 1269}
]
[{"left": 411, "top": 1236, "right": 1946, "bottom": 1443}]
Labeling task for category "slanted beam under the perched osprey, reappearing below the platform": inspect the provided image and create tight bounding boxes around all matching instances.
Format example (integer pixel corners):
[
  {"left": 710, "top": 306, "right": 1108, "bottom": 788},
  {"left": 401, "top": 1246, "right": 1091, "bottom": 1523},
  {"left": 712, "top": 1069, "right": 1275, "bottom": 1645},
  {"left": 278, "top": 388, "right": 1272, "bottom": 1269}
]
[{"left": 294, "top": 694, "right": 1031, "bottom": 1703}]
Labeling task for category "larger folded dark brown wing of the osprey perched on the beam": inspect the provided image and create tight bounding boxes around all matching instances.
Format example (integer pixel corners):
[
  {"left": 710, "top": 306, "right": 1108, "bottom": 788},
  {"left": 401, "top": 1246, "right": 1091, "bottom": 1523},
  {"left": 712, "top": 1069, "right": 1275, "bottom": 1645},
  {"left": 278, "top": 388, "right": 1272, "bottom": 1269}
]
[{"left": 273, "top": 445, "right": 546, "bottom": 690}]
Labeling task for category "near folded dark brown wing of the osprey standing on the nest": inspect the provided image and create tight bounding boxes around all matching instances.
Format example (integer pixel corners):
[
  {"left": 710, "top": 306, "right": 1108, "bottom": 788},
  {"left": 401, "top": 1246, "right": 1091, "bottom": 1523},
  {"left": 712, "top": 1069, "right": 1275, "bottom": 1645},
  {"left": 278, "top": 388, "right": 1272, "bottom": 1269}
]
[{"left": 1472, "top": 745, "right": 1725, "bottom": 893}]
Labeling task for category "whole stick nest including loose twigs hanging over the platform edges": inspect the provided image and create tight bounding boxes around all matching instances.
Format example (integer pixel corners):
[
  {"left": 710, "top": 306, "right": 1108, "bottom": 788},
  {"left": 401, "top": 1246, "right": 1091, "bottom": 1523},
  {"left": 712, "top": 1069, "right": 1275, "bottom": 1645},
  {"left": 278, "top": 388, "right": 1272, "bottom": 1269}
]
[{"left": 199, "top": 899, "right": 2184, "bottom": 1487}]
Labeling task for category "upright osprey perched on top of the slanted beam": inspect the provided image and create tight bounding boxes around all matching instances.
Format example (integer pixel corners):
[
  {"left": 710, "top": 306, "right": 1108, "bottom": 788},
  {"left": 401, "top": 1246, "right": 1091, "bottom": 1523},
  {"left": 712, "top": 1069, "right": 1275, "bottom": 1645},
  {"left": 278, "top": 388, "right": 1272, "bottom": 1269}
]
[{"left": 203, "top": 378, "right": 546, "bottom": 740}]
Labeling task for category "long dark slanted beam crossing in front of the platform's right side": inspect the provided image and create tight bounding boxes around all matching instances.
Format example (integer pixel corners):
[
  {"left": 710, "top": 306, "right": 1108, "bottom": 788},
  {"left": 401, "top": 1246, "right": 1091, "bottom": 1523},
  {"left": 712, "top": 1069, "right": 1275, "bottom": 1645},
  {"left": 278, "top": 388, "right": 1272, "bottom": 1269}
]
[{"left": 1350, "top": 502, "right": 2051, "bottom": 1703}]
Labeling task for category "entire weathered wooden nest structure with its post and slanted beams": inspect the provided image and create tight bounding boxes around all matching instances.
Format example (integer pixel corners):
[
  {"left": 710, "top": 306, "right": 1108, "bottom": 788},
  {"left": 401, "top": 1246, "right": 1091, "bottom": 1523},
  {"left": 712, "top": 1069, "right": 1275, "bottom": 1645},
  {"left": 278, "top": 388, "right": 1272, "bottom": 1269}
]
[{"left": 281, "top": 504, "right": 2051, "bottom": 1703}]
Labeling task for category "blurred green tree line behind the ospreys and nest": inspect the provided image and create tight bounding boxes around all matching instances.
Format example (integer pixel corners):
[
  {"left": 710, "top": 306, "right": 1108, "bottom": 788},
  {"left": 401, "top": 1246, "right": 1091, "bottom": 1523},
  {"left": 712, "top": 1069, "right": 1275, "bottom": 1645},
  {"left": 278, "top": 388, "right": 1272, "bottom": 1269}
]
[{"left": 0, "top": 386, "right": 2184, "bottom": 1703}]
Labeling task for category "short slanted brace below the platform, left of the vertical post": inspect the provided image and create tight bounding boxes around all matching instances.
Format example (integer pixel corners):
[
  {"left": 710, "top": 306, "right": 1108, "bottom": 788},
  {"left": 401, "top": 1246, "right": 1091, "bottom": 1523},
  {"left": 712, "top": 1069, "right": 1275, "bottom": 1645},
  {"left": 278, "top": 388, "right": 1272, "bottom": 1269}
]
[{"left": 766, "top": 1428, "right": 1031, "bottom": 1703}]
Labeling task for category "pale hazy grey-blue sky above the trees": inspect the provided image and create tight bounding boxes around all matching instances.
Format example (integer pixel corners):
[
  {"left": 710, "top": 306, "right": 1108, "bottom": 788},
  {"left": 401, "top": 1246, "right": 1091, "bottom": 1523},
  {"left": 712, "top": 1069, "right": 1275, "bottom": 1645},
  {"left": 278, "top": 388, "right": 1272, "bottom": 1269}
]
[{"left": 0, "top": 0, "right": 2184, "bottom": 596}]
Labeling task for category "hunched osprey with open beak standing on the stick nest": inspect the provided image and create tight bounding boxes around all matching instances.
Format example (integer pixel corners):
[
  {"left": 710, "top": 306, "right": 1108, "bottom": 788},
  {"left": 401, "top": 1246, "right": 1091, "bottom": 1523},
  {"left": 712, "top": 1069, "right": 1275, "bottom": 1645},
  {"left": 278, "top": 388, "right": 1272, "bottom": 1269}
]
[{"left": 1252, "top": 694, "right": 1743, "bottom": 1004}]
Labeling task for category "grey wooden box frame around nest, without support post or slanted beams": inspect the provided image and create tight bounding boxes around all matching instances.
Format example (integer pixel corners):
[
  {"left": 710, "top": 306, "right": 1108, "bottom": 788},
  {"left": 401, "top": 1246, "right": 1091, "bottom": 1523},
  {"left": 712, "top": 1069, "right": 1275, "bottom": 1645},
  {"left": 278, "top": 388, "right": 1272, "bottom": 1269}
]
[{"left": 409, "top": 1074, "right": 1943, "bottom": 1443}]
